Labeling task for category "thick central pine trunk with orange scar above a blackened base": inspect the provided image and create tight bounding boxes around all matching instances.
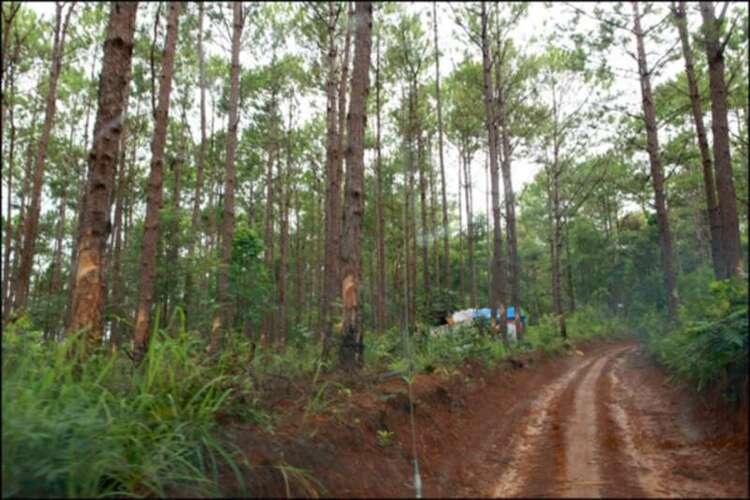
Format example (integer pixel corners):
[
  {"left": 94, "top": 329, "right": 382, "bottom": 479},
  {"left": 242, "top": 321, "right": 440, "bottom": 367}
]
[{"left": 339, "top": 2, "right": 372, "bottom": 368}]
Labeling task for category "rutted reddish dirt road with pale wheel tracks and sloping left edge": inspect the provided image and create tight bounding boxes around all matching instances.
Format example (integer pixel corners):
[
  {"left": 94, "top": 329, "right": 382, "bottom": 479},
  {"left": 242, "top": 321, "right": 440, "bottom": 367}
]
[{"left": 425, "top": 343, "right": 748, "bottom": 498}]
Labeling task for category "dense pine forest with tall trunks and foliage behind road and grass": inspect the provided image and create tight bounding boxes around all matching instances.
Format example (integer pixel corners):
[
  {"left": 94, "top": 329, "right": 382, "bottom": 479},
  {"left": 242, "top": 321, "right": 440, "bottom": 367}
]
[{"left": 2, "top": 2, "right": 749, "bottom": 498}]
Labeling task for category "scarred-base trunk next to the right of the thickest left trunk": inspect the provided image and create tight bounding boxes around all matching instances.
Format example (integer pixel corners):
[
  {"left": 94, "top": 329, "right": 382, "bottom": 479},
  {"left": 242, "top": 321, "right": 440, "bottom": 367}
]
[{"left": 133, "top": 2, "right": 182, "bottom": 363}]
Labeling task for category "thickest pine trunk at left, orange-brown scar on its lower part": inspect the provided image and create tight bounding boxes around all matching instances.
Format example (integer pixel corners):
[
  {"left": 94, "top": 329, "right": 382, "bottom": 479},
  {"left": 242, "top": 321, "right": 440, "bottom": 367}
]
[{"left": 68, "top": 2, "right": 138, "bottom": 345}]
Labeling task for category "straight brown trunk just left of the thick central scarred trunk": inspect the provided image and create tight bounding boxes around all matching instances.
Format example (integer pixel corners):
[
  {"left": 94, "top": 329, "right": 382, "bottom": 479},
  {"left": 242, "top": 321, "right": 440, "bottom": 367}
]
[{"left": 320, "top": 2, "right": 343, "bottom": 357}]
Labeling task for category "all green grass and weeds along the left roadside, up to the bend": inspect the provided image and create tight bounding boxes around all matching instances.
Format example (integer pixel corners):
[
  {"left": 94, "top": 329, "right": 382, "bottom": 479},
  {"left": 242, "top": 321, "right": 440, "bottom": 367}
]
[{"left": 2, "top": 309, "right": 636, "bottom": 497}]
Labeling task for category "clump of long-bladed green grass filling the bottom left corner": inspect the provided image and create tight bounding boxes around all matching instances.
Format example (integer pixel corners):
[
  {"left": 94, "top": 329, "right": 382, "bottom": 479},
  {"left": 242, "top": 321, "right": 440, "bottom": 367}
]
[{"left": 2, "top": 322, "right": 250, "bottom": 497}]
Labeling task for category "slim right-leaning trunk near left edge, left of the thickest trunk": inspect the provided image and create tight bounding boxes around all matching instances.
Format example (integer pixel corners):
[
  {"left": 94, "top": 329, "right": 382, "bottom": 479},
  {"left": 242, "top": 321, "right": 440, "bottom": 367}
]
[{"left": 15, "top": 2, "right": 76, "bottom": 313}]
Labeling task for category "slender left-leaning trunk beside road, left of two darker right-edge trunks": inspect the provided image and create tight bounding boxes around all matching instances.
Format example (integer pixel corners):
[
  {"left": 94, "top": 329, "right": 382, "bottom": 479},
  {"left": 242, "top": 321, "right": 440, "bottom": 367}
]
[{"left": 632, "top": 2, "right": 680, "bottom": 320}]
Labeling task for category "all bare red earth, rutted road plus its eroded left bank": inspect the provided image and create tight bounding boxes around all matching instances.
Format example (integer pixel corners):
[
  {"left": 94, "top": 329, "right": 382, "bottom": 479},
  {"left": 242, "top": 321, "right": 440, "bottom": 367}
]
[{"left": 216, "top": 341, "right": 748, "bottom": 497}]
